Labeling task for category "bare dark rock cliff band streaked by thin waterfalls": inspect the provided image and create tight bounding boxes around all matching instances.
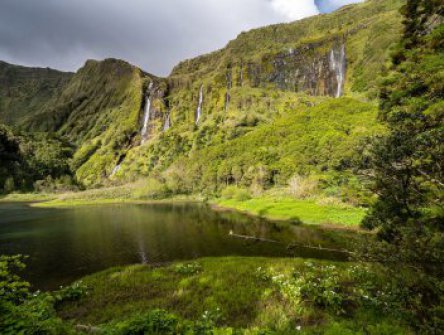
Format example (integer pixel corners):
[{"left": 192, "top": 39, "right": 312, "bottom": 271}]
[{"left": 169, "top": 39, "right": 347, "bottom": 109}]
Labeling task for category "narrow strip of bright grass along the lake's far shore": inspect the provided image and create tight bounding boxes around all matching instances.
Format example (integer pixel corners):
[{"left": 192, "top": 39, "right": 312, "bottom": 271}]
[{"left": 0, "top": 192, "right": 366, "bottom": 230}]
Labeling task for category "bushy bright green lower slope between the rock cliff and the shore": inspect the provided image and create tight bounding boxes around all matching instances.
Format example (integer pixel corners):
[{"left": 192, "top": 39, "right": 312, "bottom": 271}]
[{"left": 116, "top": 94, "right": 385, "bottom": 200}]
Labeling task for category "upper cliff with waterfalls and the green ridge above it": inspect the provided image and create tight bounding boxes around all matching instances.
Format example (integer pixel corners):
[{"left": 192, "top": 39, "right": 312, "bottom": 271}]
[{"left": 164, "top": 0, "right": 403, "bottom": 127}]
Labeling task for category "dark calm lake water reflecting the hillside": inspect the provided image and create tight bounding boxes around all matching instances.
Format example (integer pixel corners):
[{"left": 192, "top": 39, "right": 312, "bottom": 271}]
[{"left": 0, "top": 203, "right": 345, "bottom": 289}]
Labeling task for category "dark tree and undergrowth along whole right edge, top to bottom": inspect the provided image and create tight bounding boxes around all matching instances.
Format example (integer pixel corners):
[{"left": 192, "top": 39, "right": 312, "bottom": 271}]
[{"left": 364, "top": 0, "right": 444, "bottom": 334}]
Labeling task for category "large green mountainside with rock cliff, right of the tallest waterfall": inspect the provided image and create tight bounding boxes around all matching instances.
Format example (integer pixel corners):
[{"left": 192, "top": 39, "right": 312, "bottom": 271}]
[{"left": 110, "top": 0, "right": 403, "bottom": 191}]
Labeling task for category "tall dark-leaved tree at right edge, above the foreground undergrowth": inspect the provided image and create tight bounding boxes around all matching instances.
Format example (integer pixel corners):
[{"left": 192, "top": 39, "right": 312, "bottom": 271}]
[{"left": 364, "top": 0, "right": 444, "bottom": 242}]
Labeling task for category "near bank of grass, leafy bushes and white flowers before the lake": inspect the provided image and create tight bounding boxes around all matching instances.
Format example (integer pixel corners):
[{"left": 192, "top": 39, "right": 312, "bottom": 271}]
[{"left": 0, "top": 257, "right": 413, "bottom": 335}]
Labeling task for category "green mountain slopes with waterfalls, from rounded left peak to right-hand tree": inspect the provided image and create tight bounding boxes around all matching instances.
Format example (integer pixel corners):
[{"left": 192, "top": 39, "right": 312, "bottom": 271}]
[{"left": 0, "top": 0, "right": 403, "bottom": 191}]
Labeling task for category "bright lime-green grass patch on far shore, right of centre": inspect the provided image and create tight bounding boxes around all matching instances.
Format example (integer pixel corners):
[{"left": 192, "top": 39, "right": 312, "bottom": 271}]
[{"left": 214, "top": 197, "right": 366, "bottom": 227}]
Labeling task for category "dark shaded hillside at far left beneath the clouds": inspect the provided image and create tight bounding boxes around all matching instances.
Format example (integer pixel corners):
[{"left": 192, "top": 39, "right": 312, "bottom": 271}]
[{"left": 0, "top": 61, "right": 73, "bottom": 126}]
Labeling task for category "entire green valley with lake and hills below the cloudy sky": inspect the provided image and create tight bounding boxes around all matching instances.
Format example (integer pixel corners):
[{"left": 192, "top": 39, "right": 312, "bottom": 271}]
[{"left": 0, "top": 0, "right": 444, "bottom": 335}]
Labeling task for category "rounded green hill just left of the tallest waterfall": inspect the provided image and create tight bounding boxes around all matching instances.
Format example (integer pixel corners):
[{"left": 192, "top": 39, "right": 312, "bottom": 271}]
[{"left": 26, "top": 59, "right": 168, "bottom": 185}]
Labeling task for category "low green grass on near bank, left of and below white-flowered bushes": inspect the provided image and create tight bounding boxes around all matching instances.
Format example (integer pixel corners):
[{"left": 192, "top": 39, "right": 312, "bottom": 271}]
[{"left": 58, "top": 257, "right": 409, "bottom": 335}]
